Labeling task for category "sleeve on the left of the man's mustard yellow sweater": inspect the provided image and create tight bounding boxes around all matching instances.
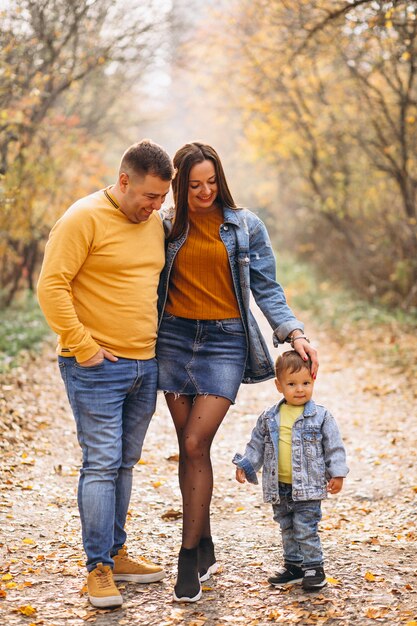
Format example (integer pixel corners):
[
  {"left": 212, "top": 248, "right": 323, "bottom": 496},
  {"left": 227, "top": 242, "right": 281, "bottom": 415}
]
[{"left": 38, "top": 207, "right": 100, "bottom": 362}]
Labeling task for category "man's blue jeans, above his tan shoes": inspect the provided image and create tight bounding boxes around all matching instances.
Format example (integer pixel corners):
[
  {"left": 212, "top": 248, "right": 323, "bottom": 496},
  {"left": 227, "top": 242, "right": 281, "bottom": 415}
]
[{"left": 58, "top": 356, "right": 158, "bottom": 571}]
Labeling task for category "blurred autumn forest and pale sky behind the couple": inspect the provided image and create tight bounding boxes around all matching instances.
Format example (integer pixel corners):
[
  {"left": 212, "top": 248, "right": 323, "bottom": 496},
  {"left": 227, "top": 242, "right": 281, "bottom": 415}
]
[{"left": 0, "top": 0, "right": 417, "bottom": 315}]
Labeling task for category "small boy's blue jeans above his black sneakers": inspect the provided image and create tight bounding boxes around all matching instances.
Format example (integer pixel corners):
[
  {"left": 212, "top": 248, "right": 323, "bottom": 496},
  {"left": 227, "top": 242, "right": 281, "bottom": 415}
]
[{"left": 272, "top": 482, "right": 323, "bottom": 569}]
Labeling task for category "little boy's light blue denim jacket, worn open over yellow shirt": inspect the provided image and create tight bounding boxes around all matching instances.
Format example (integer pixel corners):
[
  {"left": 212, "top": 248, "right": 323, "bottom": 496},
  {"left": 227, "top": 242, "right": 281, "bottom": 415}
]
[{"left": 233, "top": 400, "right": 349, "bottom": 504}]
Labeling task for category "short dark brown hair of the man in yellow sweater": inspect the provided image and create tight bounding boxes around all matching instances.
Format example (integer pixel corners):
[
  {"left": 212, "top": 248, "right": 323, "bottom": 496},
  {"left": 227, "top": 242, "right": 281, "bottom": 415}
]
[{"left": 119, "top": 139, "right": 174, "bottom": 181}]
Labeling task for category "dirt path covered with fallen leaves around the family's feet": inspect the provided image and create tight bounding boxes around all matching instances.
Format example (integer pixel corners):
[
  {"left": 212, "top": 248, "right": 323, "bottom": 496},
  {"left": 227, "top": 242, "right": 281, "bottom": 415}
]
[{"left": 0, "top": 316, "right": 417, "bottom": 626}]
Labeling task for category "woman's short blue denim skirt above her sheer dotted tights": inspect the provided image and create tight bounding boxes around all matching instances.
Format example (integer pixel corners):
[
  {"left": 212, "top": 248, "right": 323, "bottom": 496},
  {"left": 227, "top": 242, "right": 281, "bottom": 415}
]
[{"left": 156, "top": 313, "right": 247, "bottom": 403}]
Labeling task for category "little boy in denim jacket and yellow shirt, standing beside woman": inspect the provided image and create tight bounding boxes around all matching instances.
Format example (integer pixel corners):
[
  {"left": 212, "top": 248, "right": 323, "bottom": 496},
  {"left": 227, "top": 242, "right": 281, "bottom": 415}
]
[{"left": 233, "top": 350, "right": 349, "bottom": 591}]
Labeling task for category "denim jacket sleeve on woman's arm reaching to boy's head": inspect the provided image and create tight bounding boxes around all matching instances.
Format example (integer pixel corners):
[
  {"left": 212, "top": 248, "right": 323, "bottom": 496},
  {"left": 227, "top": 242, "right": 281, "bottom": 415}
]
[{"left": 249, "top": 218, "right": 304, "bottom": 346}]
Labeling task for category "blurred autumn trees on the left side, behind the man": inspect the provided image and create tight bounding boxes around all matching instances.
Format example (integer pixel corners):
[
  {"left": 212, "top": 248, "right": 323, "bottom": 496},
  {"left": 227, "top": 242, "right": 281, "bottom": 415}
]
[{"left": 0, "top": 0, "right": 169, "bottom": 305}]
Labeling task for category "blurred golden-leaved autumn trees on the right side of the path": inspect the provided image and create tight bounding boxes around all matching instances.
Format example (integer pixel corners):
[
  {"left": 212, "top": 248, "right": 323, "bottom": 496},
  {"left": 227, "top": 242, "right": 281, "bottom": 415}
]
[{"left": 197, "top": 0, "right": 417, "bottom": 308}]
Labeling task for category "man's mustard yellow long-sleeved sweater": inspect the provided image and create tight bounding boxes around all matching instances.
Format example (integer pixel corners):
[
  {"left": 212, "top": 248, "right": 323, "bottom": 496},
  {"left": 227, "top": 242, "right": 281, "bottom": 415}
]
[{"left": 38, "top": 191, "right": 165, "bottom": 362}]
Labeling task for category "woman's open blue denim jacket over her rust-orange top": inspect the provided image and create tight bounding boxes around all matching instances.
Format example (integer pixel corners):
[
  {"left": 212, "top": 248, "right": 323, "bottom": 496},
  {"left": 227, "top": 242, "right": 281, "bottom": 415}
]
[{"left": 158, "top": 207, "right": 304, "bottom": 383}]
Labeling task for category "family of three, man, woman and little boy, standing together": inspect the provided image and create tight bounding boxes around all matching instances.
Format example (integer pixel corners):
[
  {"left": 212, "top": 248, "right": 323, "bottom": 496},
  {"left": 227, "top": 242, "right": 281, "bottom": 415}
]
[{"left": 38, "top": 140, "right": 348, "bottom": 608}]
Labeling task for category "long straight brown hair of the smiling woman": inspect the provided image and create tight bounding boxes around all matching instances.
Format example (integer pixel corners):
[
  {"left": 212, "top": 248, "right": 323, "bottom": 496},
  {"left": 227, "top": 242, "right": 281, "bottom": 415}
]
[{"left": 169, "top": 141, "right": 236, "bottom": 241}]
